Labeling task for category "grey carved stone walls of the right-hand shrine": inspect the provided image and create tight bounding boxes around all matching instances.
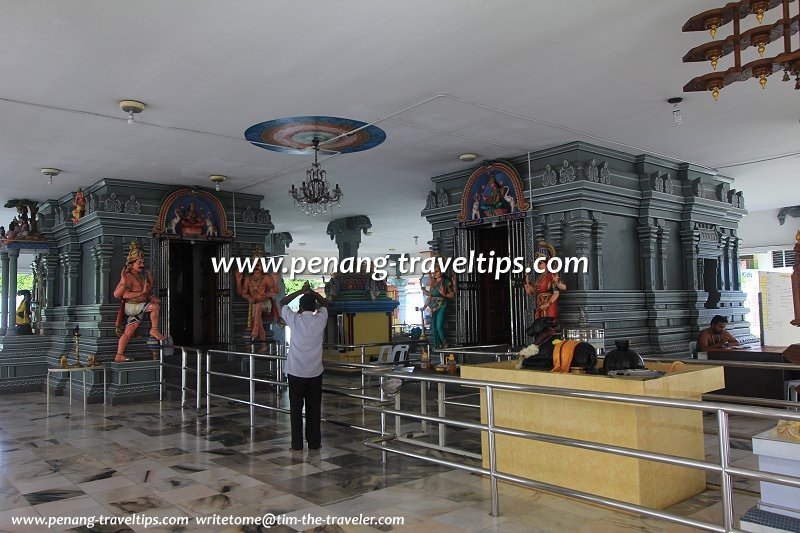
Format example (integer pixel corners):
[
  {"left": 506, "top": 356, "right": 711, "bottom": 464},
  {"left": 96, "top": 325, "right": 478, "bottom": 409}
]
[{"left": 422, "top": 142, "right": 755, "bottom": 356}]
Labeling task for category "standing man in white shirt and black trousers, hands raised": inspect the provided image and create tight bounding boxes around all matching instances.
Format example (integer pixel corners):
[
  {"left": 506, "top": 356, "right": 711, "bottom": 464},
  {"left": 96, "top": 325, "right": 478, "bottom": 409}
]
[{"left": 280, "top": 282, "right": 328, "bottom": 452}]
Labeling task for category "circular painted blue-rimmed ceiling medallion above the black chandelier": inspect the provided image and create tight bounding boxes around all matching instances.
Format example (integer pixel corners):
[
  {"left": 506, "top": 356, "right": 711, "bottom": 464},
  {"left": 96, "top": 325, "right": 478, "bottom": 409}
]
[{"left": 244, "top": 117, "right": 386, "bottom": 154}]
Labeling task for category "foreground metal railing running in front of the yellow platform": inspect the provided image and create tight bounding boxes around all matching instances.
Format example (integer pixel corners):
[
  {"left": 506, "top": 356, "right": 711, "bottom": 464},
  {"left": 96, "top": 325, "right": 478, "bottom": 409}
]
[{"left": 364, "top": 370, "right": 800, "bottom": 531}]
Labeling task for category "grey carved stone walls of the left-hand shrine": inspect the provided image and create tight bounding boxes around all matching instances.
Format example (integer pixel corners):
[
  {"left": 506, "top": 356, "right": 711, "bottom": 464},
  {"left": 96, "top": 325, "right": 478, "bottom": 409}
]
[{"left": 0, "top": 179, "right": 276, "bottom": 394}]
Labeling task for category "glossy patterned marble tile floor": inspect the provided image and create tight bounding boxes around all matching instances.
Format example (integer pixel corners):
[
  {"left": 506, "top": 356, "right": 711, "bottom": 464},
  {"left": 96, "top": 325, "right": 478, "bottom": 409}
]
[{"left": 0, "top": 376, "right": 764, "bottom": 533}]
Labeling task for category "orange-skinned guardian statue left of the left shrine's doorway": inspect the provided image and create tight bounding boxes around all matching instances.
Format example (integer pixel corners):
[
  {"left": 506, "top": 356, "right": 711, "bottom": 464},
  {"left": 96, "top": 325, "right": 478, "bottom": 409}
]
[{"left": 114, "top": 240, "right": 164, "bottom": 362}]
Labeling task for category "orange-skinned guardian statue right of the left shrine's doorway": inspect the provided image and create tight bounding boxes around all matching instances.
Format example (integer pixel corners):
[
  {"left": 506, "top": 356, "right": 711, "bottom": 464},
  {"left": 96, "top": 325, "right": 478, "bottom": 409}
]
[{"left": 236, "top": 246, "right": 286, "bottom": 348}]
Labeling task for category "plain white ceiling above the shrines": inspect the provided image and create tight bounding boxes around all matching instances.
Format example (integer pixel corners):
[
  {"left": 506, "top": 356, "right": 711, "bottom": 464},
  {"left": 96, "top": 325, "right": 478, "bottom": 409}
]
[{"left": 0, "top": 0, "right": 800, "bottom": 262}]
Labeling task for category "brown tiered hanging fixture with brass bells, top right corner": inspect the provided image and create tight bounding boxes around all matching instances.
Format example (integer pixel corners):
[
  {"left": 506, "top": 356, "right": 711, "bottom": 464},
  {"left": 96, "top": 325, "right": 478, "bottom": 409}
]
[{"left": 683, "top": 0, "right": 800, "bottom": 100}]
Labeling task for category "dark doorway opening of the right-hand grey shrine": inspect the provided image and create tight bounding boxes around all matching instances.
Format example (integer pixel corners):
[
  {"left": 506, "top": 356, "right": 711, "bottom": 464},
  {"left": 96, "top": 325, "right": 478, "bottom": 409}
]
[{"left": 476, "top": 224, "right": 511, "bottom": 344}]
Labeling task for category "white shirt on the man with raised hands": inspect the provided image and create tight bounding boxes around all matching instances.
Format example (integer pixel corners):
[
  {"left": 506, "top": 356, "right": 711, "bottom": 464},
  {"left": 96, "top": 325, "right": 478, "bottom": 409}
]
[{"left": 281, "top": 305, "right": 328, "bottom": 378}]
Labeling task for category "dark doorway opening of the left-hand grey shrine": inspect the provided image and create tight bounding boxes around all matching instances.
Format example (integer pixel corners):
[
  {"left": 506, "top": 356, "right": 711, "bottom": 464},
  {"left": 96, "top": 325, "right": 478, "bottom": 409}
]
[{"left": 169, "top": 241, "right": 219, "bottom": 346}]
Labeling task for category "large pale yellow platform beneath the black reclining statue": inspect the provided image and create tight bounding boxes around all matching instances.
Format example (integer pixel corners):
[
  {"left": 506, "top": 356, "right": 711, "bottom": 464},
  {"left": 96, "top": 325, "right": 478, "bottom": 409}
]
[{"left": 461, "top": 361, "right": 725, "bottom": 509}]
